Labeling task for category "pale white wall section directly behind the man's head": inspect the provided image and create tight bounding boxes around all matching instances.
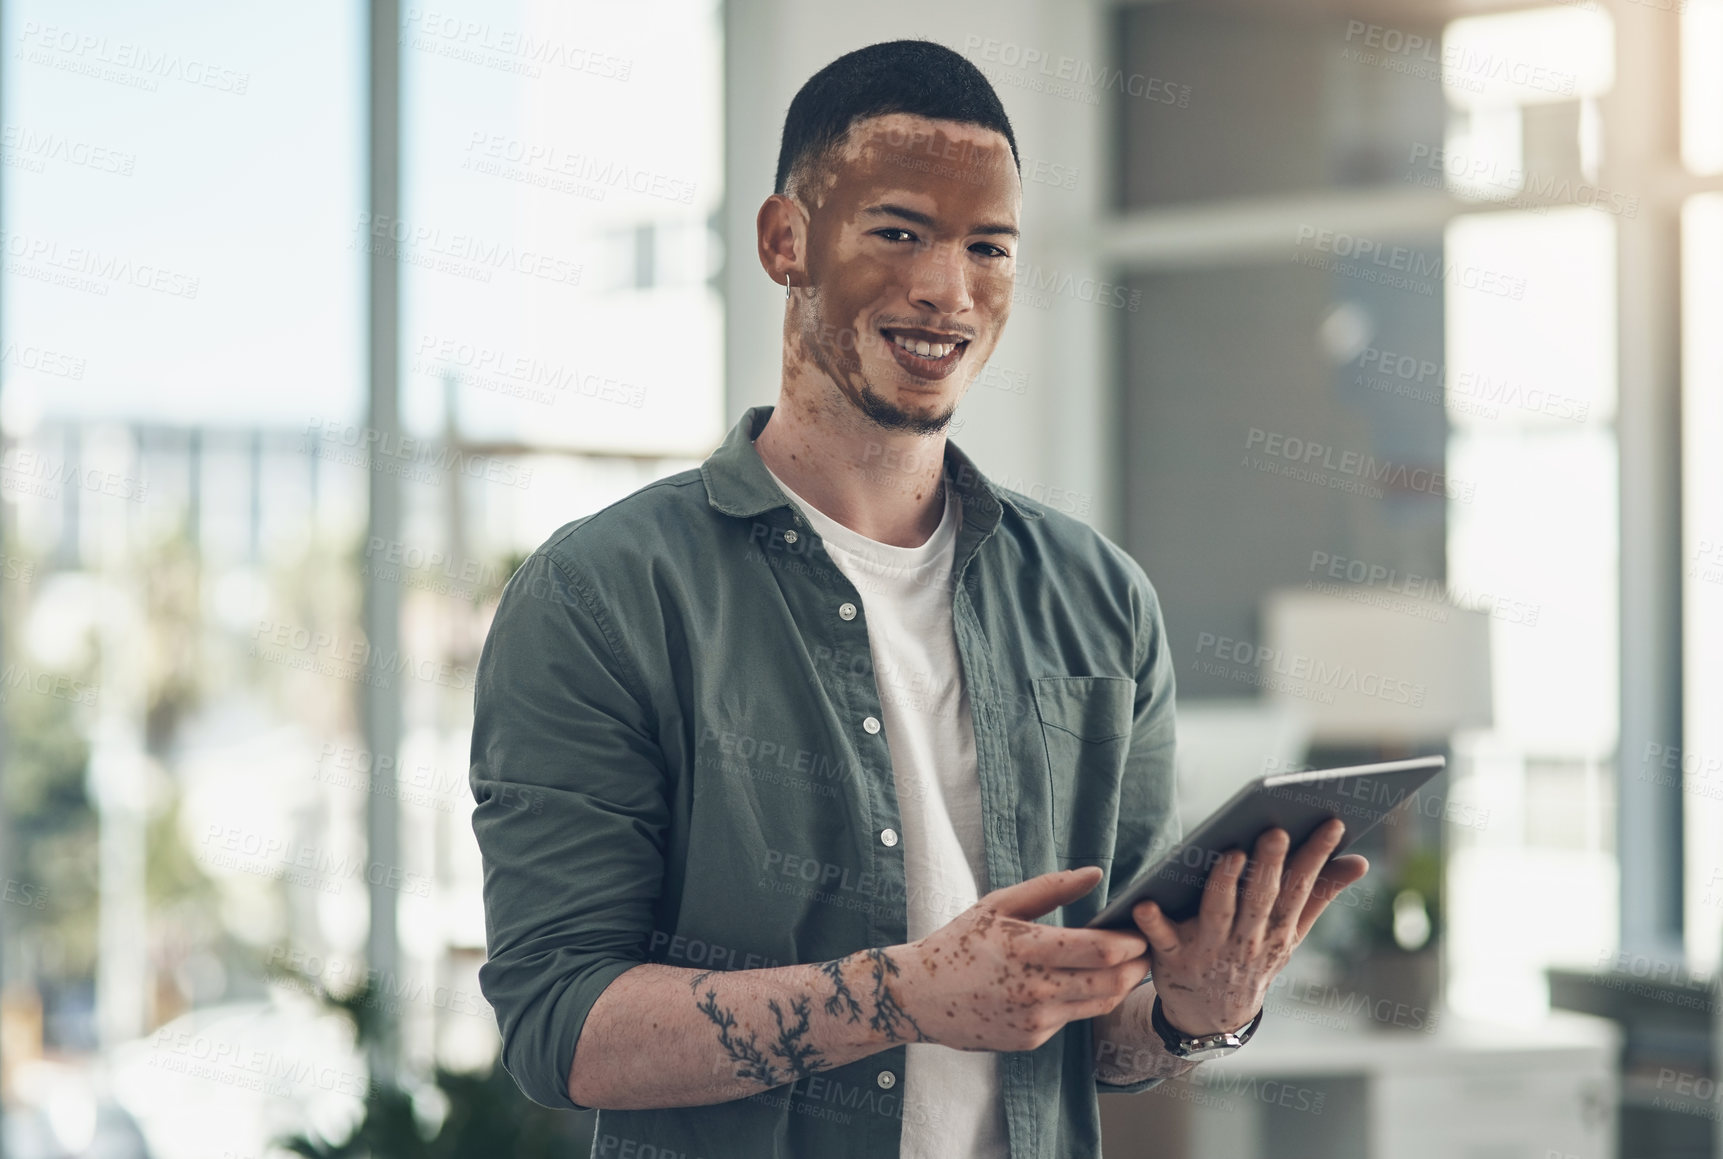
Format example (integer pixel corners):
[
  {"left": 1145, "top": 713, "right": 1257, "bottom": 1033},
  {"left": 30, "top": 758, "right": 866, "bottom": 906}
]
[{"left": 724, "top": 0, "right": 1130, "bottom": 537}]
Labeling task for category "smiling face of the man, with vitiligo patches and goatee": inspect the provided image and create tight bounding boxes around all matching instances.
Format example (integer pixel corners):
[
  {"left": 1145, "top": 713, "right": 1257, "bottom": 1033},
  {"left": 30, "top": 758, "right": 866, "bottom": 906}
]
[{"left": 789, "top": 114, "right": 1022, "bottom": 434}]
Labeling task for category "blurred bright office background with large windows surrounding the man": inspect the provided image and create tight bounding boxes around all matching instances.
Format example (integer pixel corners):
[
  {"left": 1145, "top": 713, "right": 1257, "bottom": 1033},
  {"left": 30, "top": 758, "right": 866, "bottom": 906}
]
[{"left": 0, "top": 0, "right": 1723, "bottom": 1159}]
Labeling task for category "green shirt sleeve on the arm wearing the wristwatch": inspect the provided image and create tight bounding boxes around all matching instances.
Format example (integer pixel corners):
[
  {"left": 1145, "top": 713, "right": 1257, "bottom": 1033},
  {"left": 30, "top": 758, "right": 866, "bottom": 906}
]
[{"left": 1096, "top": 572, "right": 1184, "bottom": 1094}]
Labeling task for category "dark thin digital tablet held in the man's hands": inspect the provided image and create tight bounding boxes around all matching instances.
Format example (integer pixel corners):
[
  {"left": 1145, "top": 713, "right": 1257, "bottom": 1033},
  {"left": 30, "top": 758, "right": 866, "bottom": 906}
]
[{"left": 1089, "top": 756, "right": 1447, "bottom": 930}]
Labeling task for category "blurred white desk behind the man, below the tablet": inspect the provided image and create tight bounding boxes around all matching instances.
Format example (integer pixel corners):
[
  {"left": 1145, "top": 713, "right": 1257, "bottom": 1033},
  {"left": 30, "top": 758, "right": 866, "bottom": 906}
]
[{"left": 1101, "top": 1006, "right": 1621, "bottom": 1159}]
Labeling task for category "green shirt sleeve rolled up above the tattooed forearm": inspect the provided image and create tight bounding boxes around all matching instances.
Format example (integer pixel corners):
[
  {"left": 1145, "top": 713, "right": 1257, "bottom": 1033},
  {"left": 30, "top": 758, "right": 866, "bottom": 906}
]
[{"left": 469, "top": 551, "right": 669, "bottom": 1111}]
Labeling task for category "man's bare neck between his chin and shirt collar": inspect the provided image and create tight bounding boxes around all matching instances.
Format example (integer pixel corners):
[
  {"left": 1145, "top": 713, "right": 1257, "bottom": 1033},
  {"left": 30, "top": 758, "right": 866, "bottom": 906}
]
[{"left": 755, "top": 398, "right": 946, "bottom": 548}]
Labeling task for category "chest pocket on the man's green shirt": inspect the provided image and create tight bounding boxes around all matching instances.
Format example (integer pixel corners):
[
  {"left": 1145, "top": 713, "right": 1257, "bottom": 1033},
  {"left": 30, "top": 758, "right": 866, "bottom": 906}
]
[{"left": 1034, "top": 677, "right": 1137, "bottom": 861}]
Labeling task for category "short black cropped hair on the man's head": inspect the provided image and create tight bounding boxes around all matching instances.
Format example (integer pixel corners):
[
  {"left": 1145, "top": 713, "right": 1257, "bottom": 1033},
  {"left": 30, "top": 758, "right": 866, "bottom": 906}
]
[{"left": 772, "top": 40, "right": 1023, "bottom": 193}]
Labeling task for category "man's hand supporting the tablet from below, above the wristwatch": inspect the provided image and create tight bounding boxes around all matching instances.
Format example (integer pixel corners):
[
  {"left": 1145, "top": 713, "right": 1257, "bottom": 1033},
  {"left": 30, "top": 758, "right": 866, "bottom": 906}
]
[{"left": 1132, "top": 818, "right": 1370, "bottom": 1035}]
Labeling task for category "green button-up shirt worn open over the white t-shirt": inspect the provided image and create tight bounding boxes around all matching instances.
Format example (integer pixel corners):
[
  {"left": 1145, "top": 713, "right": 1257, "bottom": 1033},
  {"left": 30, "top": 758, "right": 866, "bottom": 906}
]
[{"left": 470, "top": 406, "right": 1180, "bottom": 1159}]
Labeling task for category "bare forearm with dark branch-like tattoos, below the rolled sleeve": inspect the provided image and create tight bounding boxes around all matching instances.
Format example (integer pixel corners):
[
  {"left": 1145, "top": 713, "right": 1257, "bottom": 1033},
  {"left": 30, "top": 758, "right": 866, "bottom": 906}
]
[{"left": 569, "top": 947, "right": 918, "bottom": 1111}]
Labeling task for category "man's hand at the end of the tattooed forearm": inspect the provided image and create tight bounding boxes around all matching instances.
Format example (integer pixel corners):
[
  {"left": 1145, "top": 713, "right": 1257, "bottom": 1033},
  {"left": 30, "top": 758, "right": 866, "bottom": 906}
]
[{"left": 891, "top": 866, "right": 1149, "bottom": 1051}]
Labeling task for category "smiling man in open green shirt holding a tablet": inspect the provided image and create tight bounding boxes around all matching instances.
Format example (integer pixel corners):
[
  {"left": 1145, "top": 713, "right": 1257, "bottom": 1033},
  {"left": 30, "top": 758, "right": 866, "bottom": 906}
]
[{"left": 472, "top": 41, "right": 1365, "bottom": 1159}]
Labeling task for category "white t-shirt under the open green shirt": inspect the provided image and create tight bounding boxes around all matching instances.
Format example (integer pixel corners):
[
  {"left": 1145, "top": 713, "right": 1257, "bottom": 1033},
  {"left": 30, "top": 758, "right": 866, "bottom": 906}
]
[{"left": 767, "top": 468, "right": 1010, "bottom": 1159}]
